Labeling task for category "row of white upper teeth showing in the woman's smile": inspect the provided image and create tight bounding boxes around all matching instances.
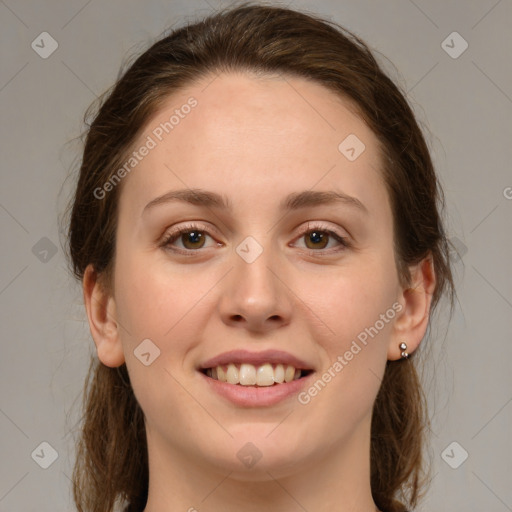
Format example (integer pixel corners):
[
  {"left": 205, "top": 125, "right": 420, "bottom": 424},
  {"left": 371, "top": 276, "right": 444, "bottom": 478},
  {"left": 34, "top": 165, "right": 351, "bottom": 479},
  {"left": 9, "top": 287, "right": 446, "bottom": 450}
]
[{"left": 206, "top": 363, "right": 301, "bottom": 386}]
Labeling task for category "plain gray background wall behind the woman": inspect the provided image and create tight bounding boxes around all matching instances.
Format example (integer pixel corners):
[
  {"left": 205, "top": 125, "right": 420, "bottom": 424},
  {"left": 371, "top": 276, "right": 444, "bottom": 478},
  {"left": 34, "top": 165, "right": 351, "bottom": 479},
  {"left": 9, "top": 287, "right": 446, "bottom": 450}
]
[{"left": 0, "top": 0, "right": 512, "bottom": 512}]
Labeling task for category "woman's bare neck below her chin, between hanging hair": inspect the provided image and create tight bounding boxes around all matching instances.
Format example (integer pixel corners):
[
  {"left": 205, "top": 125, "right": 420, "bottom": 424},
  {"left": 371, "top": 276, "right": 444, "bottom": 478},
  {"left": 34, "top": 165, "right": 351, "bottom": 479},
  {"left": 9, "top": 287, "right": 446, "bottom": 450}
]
[{"left": 144, "top": 421, "right": 377, "bottom": 512}]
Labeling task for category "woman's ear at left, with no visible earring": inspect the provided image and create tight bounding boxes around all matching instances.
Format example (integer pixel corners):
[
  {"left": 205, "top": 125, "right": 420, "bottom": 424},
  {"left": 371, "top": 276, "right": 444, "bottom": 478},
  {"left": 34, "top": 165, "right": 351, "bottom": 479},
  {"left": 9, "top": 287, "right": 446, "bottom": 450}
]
[{"left": 82, "top": 265, "right": 125, "bottom": 368}]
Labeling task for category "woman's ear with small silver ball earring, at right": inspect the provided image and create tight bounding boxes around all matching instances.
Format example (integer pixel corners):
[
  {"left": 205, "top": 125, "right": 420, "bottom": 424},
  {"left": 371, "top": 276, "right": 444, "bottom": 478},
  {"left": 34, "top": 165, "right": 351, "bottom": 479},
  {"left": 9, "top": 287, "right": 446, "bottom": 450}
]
[{"left": 388, "top": 255, "right": 436, "bottom": 361}]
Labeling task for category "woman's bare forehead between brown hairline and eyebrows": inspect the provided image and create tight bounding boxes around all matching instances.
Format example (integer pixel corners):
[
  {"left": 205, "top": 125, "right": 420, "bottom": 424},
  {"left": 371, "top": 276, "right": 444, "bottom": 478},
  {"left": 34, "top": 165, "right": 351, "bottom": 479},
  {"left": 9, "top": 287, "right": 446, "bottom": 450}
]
[{"left": 121, "top": 69, "right": 383, "bottom": 216}]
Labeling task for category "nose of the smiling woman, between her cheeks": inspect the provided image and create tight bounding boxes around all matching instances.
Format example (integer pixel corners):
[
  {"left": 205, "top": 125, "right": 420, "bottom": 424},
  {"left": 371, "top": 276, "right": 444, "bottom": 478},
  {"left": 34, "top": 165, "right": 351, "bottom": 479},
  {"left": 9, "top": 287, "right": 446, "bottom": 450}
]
[{"left": 219, "top": 242, "right": 293, "bottom": 332}]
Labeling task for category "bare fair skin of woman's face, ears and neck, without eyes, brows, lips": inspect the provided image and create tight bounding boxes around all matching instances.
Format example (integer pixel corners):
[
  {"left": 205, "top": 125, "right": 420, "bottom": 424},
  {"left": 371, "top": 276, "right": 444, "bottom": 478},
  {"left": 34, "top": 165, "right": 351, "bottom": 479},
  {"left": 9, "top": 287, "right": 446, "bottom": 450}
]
[{"left": 83, "top": 73, "right": 435, "bottom": 512}]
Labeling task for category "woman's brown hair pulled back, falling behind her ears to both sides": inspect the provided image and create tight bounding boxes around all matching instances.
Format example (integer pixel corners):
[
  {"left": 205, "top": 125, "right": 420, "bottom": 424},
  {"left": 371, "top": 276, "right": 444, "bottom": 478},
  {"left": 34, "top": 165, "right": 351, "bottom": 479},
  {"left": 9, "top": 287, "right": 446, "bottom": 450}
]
[{"left": 67, "top": 2, "right": 454, "bottom": 512}]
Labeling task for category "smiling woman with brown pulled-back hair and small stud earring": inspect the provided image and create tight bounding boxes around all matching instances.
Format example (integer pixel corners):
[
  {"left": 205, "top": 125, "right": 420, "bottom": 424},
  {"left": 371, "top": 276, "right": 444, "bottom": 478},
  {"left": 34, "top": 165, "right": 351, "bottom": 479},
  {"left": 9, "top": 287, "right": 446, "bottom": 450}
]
[{"left": 69, "top": 4, "right": 454, "bottom": 512}]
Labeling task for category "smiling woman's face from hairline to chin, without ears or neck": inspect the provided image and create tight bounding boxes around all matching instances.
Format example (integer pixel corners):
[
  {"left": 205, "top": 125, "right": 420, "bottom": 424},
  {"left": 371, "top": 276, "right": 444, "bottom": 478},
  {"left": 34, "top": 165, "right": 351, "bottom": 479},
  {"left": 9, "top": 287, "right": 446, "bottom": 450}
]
[{"left": 101, "top": 74, "right": 412, "bottom": 479}]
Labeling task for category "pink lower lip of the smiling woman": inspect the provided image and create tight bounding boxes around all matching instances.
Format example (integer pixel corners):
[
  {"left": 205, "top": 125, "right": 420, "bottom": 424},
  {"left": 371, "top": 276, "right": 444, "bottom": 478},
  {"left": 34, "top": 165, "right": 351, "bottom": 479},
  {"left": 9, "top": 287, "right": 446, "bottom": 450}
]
[{"left": 199, "top": 372, "right": 315, "bottom": 407}]
